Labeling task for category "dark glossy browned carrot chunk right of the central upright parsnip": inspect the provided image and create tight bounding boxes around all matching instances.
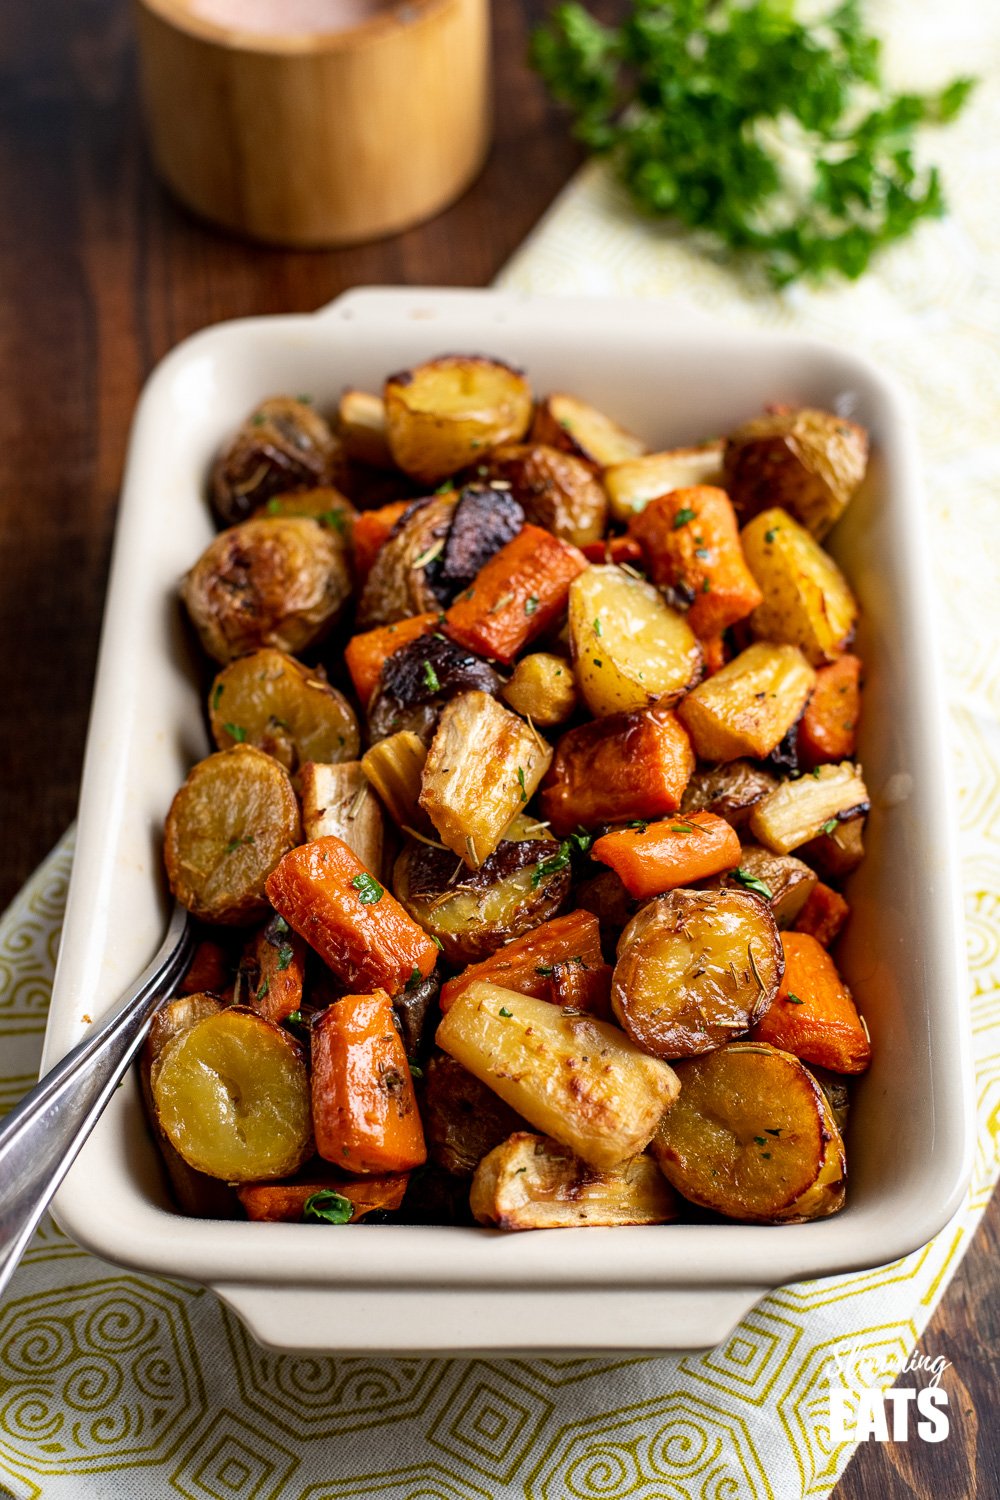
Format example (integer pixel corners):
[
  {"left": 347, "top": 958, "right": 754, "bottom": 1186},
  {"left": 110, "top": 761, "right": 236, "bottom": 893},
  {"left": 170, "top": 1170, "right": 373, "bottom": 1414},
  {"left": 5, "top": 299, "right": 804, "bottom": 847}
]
[{"left": 541, "top": 708, "right": 694, "bottom": 839}]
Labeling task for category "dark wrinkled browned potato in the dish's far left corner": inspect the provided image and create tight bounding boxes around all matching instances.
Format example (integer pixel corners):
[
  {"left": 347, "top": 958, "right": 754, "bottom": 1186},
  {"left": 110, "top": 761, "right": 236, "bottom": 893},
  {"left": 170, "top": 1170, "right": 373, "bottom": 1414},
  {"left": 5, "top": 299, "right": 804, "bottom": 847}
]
[{"left": 211, "top": 396, "right": 336, "bottom": 527}]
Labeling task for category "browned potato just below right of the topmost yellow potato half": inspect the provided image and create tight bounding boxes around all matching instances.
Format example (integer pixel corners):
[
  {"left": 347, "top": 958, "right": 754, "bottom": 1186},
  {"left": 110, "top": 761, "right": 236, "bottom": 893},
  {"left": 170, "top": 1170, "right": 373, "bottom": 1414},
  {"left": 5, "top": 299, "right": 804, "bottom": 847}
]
[{"left": 484, "top": 443, "right": 607, "bottom": 548}]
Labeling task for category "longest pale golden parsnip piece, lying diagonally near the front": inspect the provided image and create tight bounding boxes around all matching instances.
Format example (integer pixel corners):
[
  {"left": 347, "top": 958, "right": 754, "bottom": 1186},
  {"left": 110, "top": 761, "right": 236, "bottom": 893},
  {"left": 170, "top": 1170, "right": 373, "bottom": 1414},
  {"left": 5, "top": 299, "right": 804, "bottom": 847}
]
[{"left": 436, "top": 981, "right": 678, "bottom": 1170}]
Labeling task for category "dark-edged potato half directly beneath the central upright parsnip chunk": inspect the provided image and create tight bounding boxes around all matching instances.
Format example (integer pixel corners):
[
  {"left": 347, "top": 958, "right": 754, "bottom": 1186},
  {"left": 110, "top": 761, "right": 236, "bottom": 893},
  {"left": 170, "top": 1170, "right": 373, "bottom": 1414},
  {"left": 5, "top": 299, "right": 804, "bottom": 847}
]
[{"left": 393, "top": 815, "right": 570, "bottom": 965}]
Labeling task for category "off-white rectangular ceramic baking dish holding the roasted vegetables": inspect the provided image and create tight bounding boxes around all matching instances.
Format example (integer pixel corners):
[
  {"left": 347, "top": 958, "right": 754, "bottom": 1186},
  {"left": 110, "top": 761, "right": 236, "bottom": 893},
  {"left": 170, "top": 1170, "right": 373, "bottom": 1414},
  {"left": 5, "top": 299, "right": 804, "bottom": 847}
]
[{"left": 45, "top": 290, "right": 973, "bottom": 1353}]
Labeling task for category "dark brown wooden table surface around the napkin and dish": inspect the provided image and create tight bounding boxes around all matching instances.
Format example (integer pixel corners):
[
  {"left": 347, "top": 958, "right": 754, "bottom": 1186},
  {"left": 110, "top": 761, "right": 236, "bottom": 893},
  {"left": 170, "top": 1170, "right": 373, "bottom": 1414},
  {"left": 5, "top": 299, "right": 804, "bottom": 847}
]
[{"left": 0, "top": 0, "right": 1000, "bottom": 1500}]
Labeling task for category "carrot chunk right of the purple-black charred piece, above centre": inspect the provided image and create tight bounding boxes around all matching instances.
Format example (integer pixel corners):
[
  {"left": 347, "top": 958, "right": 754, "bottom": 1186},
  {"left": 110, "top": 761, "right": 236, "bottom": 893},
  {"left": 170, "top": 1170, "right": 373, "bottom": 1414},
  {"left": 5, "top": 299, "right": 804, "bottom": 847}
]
[{"left": 444, "top": 525, "right": 586, "bottom": 665}]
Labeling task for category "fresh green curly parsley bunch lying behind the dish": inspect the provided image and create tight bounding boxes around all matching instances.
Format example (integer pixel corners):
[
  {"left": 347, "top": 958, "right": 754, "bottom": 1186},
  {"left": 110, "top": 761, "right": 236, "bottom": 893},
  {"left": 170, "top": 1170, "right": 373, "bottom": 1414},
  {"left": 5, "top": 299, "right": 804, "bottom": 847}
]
[{"left": 532, "top": 0, "right": 973, "bottom": 287}]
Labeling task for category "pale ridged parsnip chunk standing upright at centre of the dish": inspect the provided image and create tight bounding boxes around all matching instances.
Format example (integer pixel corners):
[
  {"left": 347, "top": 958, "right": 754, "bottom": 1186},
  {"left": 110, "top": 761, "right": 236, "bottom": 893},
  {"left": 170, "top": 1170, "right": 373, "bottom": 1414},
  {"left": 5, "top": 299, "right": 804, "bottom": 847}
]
[{"left": 420, "top": 693, "right": 552, "bottom": 869}]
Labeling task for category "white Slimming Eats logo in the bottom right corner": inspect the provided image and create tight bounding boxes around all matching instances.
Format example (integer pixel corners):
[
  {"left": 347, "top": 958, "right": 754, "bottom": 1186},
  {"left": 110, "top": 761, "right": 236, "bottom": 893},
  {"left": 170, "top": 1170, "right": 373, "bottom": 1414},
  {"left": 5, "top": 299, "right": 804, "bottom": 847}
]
[{"left": 828, "top": 1344, "right": 951, "bottom": 1443}]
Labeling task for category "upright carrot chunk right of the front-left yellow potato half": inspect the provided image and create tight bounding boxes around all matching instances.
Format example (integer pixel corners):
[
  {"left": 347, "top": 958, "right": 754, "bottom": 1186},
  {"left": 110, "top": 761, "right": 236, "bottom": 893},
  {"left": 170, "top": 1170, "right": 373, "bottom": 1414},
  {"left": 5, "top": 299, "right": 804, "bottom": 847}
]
[{"left": 312, "top": 990, "right": 427, "bottom": 1173}]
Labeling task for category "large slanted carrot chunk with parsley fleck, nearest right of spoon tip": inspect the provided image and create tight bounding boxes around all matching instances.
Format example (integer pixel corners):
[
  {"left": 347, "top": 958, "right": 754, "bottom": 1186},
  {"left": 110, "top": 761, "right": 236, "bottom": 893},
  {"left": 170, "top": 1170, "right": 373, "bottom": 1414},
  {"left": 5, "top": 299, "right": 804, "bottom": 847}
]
[{"left": 267, "top": 834, "right": 438, "bottom": 995}]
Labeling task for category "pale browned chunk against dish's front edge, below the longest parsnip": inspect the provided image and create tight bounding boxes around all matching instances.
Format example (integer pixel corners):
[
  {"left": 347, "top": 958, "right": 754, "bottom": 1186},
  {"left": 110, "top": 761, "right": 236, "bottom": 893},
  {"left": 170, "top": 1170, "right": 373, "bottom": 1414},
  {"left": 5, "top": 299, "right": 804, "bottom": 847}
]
[{"left": 469, "top": 1131, "right": 678, "bottom": 1230}]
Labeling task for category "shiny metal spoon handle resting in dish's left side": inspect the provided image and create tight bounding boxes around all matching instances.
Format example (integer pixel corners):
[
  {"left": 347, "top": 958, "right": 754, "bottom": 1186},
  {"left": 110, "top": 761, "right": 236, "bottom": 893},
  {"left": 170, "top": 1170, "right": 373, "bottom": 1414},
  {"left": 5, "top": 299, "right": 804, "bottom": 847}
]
[{"left": 0, "top": 906, "right": 193, "bottom": 1296}]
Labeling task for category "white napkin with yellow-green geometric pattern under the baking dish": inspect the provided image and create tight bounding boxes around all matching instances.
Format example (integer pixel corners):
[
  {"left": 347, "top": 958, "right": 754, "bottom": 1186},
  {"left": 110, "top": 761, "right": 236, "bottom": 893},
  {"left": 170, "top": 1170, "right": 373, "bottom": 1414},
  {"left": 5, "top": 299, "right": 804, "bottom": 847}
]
[{"left": 0, "top": 0, "right": 1000, "bottom": 1500}]
